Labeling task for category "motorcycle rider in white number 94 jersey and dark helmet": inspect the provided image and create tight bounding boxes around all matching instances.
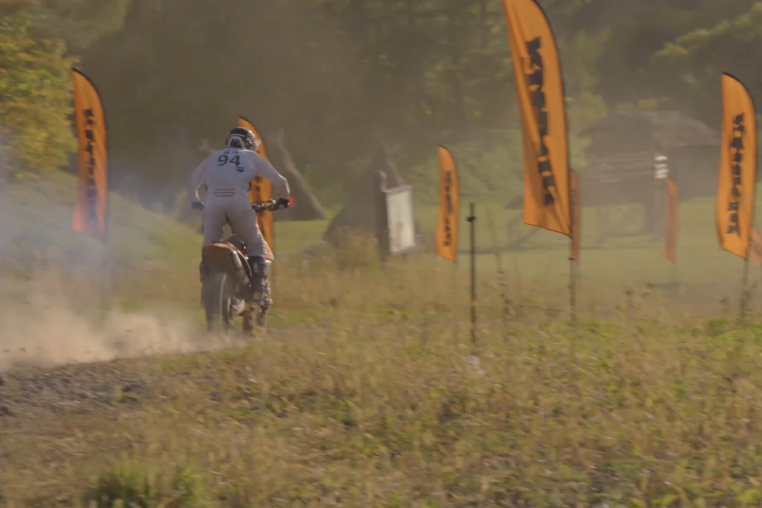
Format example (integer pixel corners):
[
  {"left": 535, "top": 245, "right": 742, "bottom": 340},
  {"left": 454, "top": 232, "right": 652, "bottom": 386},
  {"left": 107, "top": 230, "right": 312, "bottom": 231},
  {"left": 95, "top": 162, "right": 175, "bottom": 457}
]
[{"left": 188, "top": 127, "right": 291, "bottom": 302}]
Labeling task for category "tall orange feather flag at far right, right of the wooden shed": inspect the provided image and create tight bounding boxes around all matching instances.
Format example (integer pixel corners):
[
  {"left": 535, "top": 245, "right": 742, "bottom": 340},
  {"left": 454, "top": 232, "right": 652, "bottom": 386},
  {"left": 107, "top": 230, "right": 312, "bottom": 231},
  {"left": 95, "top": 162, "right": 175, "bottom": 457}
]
[{"left": 717, "top": 74, "right": 757, "bottom": 259}]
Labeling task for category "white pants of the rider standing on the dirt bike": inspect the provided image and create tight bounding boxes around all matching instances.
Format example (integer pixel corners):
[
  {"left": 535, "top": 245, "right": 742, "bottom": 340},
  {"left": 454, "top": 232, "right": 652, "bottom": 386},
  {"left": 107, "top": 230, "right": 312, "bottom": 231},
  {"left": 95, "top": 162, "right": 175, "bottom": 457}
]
[{"left": 203, "top": 197, "right": 265, "bottom": 257}]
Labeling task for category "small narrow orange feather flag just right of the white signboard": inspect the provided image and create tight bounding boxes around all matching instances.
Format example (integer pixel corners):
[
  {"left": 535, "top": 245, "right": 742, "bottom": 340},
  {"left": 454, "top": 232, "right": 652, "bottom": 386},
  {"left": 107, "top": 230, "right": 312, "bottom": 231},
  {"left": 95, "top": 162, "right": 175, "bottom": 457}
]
[{"left": 435, "top": 146, "right": 460, "bottom": 263}]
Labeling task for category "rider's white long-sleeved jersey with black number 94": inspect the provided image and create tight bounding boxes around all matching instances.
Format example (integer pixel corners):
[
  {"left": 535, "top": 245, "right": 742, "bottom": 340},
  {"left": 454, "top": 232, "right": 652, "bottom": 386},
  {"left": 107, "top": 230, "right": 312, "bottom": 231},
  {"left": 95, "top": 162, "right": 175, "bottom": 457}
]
[{"left": 188, "top": 148, "right": 291, "bottom": 203}]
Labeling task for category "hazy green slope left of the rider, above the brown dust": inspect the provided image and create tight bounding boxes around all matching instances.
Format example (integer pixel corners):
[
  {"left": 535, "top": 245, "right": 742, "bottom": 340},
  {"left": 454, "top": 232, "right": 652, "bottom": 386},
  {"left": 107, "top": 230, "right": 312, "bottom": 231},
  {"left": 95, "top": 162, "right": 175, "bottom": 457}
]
[{"left": 0, "top": 172, "right": 199, "bottom": 312}]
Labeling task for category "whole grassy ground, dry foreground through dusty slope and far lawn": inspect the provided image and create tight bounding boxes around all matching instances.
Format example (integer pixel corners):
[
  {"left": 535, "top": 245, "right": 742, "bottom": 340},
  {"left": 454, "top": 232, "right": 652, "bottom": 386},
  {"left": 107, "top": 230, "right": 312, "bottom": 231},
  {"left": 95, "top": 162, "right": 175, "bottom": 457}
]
[{"left": 0, "top": 176, "right": 762, "bottom": 508}]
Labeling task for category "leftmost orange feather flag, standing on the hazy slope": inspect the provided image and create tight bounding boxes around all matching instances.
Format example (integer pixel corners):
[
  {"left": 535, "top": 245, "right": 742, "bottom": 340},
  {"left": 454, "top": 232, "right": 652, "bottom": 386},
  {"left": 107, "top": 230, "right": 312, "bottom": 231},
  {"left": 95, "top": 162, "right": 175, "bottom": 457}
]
[{"left": 71, "top": 69, "right": 109, "bottom": 243}]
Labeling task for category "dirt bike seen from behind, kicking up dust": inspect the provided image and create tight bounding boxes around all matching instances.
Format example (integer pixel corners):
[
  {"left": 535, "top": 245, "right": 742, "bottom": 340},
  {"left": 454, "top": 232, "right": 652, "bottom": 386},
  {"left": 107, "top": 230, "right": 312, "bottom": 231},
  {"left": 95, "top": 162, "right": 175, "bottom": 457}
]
[{"left": 193, "top": 198, "right": 293, "bottom": 336}]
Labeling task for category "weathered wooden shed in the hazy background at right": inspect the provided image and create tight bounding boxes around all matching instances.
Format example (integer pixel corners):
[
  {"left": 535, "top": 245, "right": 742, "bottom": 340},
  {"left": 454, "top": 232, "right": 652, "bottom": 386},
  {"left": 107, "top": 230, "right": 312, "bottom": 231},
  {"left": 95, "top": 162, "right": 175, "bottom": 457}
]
[{"left": 581, "top": 111, "right": 720, "bottom": 239}]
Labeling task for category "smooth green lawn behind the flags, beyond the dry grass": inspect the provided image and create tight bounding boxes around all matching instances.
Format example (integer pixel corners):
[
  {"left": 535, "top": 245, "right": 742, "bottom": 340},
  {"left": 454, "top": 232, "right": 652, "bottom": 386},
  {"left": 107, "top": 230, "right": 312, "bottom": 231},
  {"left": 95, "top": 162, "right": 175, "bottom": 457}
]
[{"left": 278, "top": 185, "right": 762, "bottom": 303}]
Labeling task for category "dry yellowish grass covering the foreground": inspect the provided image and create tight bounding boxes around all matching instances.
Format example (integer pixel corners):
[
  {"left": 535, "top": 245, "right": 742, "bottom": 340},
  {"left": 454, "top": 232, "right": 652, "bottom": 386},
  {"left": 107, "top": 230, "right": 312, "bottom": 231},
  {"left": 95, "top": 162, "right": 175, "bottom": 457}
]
[{"left": 0, "top": 239, "right": 762, "bottom": 507}]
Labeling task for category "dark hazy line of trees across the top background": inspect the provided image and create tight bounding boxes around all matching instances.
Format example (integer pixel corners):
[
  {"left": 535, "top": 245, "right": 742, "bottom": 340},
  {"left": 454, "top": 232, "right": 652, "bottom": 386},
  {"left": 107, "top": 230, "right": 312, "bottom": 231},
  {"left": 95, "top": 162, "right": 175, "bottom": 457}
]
[{"left": 0, "top": 0, "right": 762, "bottom": 203}]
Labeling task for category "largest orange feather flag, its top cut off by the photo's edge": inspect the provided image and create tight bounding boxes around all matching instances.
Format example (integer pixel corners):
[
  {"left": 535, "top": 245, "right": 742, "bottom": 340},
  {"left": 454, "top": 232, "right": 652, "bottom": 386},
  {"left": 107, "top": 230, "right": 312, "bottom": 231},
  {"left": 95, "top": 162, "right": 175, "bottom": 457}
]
[{"left": 503, "top": 0, "right": 572, "bottom": 236}]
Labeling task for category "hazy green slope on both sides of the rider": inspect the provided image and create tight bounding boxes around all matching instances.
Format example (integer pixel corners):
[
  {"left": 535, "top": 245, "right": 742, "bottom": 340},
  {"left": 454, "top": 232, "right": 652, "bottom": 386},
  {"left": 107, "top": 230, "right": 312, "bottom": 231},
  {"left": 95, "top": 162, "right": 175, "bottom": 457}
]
[{"left": 0, "top": 172, "right": 326, "bottom": 320}]
